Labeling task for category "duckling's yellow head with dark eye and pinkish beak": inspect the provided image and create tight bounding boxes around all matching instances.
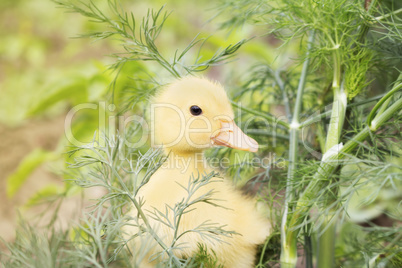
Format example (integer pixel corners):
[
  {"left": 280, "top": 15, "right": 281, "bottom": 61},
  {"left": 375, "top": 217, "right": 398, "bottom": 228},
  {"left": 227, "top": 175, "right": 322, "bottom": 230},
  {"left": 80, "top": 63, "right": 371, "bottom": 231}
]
[{"left": 151, "top": 77, "right": 258, "bottom": 153}]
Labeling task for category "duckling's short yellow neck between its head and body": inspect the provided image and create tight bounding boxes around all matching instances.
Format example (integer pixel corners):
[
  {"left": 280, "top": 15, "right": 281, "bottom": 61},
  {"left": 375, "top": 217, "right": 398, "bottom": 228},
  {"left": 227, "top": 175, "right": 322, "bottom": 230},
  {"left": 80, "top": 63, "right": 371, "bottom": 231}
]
[{"left": 164, "top": 151, "right": 211, "bottom": 174}]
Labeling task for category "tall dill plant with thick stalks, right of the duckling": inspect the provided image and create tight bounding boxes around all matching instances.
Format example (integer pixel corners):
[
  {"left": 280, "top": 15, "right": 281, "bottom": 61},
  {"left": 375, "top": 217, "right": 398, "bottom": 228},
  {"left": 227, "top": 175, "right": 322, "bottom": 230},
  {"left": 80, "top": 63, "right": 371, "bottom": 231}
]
[{"left": 214, "top": 0, "right": 402, "bottom": 267}]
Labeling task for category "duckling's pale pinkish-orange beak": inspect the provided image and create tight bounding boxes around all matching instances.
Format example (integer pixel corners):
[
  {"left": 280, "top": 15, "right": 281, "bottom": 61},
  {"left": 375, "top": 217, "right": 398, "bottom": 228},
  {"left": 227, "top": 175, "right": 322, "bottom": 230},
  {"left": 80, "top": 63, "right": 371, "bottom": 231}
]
[{"left": 211, "top": 120, "right": 258, "bottom": 152}]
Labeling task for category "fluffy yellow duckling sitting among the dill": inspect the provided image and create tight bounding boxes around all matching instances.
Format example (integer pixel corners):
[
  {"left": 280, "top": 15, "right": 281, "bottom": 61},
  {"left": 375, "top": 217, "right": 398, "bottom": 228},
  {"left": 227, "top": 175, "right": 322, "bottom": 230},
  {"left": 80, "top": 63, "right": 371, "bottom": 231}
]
[{"left": 128, "top": 77, "right": 270, "bottom": 268}]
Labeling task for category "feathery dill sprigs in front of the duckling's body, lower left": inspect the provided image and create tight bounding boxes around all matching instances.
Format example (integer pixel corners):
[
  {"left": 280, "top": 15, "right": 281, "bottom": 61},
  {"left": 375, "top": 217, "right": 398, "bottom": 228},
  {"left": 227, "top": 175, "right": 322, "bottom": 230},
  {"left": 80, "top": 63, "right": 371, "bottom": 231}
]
[{"left": 65, "top": 135, "right": 235, "bottom": 267}]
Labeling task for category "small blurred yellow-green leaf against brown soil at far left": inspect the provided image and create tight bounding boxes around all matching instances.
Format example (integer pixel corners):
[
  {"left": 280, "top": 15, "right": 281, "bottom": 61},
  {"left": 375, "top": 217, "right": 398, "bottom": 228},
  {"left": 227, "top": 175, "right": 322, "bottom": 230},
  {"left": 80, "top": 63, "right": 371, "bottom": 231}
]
[{"left": 7, "top": 148, "right": 57, "bottom": 198}]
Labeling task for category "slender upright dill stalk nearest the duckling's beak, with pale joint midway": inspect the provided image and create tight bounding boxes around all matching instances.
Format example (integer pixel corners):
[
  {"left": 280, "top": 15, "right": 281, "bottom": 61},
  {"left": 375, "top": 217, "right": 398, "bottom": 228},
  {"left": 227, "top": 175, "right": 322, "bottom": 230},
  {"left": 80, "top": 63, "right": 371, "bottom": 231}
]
[{"left": 281, "top": 32, "right": 314, "bottom": 267}]
